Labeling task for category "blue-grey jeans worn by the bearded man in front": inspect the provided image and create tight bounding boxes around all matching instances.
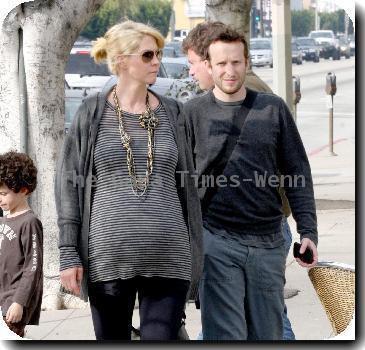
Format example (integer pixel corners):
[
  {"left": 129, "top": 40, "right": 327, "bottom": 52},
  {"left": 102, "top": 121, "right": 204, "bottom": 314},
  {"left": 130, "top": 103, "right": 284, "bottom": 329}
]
[{"left": 199, "top": 228, "right": 286, "bottom": 341}]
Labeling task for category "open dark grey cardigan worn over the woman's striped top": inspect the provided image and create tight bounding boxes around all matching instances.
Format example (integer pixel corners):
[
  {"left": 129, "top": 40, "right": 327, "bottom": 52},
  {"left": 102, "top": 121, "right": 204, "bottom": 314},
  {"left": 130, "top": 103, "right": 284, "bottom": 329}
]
[{"left": 55, "top": 84, "right": 203, "bottom": 301}]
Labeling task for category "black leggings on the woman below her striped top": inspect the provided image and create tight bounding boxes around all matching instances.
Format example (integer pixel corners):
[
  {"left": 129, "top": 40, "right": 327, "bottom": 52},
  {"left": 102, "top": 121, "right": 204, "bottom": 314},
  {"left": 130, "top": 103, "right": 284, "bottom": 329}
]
[{"left": 89, "top": 277, "right": 189, "bottom": 340}]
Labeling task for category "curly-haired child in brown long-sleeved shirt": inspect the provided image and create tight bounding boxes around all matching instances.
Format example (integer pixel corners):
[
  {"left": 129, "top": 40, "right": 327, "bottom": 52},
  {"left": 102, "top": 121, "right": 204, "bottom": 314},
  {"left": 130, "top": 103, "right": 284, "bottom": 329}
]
[{"left": 0, "top": 151, "right": 43, "bottom": 337}]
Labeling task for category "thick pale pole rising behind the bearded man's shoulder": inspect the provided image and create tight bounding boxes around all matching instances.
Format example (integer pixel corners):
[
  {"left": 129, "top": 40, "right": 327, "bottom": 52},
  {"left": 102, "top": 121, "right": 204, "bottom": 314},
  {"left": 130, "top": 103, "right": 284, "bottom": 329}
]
[{"left": 272, "top": 0, "right": 293, "bottom": 111}]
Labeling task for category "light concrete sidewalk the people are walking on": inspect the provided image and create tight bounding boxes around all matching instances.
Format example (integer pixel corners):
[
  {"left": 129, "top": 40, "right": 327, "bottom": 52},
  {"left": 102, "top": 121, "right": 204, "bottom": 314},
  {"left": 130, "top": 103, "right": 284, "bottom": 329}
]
[{"left": 4, "top": 139, "right": 355, "bottom": 340}]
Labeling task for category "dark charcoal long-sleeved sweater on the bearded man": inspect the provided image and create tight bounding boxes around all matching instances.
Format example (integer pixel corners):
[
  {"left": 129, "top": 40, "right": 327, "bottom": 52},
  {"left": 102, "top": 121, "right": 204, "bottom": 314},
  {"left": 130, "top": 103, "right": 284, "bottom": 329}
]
[{"left": 184, "top": 90, "right": 318, "bottom": 244}]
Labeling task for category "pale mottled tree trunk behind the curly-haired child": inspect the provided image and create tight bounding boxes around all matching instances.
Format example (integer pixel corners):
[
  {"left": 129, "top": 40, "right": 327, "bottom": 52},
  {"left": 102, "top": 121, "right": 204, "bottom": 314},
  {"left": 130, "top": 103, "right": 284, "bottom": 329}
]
[{"left": 0, "top": 0, "right": 105, "bottom": 309}]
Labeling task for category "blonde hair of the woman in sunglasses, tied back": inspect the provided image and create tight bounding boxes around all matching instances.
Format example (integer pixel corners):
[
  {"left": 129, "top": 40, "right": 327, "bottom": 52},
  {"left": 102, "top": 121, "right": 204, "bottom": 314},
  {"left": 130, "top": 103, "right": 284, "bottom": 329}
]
[{"left": 91, "top": 21, "right": 165, "bottom": 74}]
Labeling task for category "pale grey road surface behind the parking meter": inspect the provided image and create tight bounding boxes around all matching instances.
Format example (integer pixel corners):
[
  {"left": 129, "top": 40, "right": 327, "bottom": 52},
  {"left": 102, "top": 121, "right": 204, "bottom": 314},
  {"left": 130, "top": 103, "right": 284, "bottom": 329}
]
[{"left": 253, "top": 56, "right": 355, "bottom": 153}]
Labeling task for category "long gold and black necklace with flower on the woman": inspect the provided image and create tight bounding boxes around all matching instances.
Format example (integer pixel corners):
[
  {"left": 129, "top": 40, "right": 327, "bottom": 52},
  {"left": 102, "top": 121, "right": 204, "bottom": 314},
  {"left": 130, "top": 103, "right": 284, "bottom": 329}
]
[{"left": 113, "top": 86, "right": 158, "bottom": 197}]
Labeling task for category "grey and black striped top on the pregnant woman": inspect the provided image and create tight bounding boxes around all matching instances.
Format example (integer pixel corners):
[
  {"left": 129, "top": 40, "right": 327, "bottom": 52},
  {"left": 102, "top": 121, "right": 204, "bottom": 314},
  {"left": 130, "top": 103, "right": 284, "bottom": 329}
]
[{"left": 61, "top": 102, "right": 191, "bottom": 282}]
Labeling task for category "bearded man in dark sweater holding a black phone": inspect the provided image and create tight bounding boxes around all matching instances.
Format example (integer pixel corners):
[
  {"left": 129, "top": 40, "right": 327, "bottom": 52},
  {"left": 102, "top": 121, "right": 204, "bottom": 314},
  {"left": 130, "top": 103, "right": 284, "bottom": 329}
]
[{"left": 184, "top": 23, "right": 318, "bottom": 340}]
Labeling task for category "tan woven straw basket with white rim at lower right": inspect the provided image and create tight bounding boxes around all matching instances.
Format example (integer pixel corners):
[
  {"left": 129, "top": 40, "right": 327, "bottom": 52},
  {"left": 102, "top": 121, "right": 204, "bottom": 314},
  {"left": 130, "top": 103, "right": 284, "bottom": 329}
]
[{"left": 308, "top": 262, "right": 355, "bottom": 334}]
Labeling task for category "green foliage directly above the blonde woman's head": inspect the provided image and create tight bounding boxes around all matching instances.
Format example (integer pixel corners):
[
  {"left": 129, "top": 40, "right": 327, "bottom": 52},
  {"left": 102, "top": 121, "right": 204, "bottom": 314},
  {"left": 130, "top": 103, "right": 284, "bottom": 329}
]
[{"left": 80, "top": 0, "right": 172, "bottom": 40}]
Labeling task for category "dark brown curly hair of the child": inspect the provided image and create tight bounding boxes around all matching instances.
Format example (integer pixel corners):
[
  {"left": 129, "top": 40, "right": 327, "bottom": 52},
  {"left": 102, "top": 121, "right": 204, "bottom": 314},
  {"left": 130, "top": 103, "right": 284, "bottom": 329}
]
[{"left": 0, "top": 151, "right": 37, "bottom": 193}]
